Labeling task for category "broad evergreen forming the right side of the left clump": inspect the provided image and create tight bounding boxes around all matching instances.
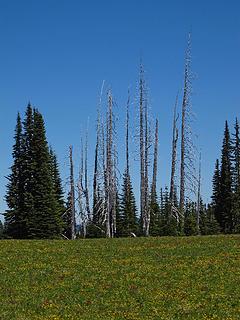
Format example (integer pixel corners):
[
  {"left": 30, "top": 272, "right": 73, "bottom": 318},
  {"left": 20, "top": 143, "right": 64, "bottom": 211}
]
[{"left": 27, "top": 110, "right": 62, "bottom": 238}]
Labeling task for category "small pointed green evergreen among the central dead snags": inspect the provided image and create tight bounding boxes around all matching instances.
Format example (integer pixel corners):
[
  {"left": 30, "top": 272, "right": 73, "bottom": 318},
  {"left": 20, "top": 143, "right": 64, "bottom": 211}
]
[{"left": 118, "top": 172, "right": 139, "bottom": 236}]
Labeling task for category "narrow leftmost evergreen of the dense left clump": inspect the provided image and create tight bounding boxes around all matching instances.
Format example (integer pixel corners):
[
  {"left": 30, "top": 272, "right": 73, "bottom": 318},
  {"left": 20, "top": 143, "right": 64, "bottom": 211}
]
[{"left": 5, "top": 113, "right": 26, "bottom": 238}]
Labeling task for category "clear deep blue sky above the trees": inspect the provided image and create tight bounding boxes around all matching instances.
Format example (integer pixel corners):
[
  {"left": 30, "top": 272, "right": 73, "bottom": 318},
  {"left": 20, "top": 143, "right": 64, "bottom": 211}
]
[{"left": 0, "top": 0, "right": 240, "bottom": 218}]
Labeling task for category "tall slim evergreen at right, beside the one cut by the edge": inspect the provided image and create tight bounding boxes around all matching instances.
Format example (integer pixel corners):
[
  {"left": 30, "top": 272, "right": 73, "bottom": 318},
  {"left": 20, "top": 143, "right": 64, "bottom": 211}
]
[{"left": 219, "top": 121, "right": 233, "bottom": 233}]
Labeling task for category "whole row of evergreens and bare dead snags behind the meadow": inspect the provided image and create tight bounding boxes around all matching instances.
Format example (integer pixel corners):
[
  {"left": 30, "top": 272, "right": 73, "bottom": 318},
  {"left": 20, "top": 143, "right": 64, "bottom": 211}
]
[{"left": 0, "top": 41, "right": 240, "bottom": 239}]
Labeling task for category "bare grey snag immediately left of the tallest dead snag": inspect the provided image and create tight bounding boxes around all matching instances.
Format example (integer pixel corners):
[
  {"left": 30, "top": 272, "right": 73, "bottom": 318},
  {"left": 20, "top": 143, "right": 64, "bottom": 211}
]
[{"left": 169, "top": 96, "right": 179, "bottom": 220}]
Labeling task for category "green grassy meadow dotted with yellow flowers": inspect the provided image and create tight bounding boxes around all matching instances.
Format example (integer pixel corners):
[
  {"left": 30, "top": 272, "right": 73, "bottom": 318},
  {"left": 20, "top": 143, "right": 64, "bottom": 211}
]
[{"left": 0, "top": 236, "right": 240, "bottom": 320}]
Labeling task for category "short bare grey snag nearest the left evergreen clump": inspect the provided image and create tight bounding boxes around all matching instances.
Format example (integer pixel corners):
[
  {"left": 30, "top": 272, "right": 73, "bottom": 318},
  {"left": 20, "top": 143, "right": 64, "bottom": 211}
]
[{"left": 69, "top": 146, "right": 76, "bottom": 240}]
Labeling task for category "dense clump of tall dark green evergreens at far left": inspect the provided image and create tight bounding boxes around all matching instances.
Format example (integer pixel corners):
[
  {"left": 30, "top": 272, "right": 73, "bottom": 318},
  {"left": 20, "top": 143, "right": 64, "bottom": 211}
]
[{"left": 5, "top": 104, "right": 64, "bottom": 238}]
